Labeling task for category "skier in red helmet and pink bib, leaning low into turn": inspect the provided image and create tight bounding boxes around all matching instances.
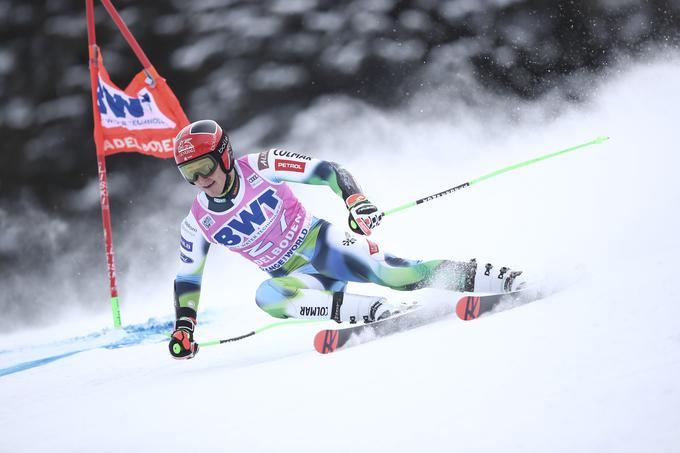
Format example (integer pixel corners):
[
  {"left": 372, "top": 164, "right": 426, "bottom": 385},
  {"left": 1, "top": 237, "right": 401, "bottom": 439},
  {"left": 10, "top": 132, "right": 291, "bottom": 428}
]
[{"left": 169, "top": 120, "right": 521, "bottom": 359}]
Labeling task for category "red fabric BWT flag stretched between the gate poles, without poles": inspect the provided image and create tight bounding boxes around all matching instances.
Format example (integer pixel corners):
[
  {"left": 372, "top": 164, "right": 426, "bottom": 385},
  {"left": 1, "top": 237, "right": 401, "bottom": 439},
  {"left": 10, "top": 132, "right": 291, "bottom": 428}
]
[{"left": 95, "top": 52, "right": 189, "bottom": 158}]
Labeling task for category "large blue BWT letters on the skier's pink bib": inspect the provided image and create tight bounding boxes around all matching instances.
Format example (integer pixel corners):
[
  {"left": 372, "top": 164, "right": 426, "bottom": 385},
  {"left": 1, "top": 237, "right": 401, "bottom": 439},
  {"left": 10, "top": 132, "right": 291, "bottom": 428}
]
[{"left": 213, "top": 188, "right": 281, "bottom": 247}]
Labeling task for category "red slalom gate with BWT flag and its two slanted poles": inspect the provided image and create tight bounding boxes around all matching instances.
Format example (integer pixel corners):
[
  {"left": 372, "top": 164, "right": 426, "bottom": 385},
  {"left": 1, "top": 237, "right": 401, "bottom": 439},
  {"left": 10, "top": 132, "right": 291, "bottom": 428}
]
[{"left": 85, "top": 0, "right": 189, "bottom": 328}]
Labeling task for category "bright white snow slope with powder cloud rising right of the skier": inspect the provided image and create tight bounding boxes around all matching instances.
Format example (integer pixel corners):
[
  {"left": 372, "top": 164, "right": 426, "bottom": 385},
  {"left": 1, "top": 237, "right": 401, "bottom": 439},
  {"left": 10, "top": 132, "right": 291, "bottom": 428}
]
[{"left": 0, "top": 56, "right": 680, "bottom": 453}]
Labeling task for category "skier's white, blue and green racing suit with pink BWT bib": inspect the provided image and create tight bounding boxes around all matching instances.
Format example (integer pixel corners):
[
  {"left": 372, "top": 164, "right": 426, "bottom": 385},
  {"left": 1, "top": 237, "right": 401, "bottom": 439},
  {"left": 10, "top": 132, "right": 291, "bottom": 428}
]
[{"left": 175, "top": 149, "right": 512, "bottom": 323}]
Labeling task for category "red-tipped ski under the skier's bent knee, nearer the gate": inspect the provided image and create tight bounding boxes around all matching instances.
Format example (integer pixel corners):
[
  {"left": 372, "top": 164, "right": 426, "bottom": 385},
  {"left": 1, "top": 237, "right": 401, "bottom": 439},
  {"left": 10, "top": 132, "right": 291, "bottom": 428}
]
[{"left": 314, "top": 306, "right": 451, "bottom": 354}]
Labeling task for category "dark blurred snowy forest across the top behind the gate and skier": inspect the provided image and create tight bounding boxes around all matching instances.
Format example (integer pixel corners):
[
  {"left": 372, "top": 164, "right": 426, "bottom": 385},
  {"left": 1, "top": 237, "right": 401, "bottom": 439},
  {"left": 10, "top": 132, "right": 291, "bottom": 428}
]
[{"left": 0, "top": 0, "right": 680, "bottom": 203}]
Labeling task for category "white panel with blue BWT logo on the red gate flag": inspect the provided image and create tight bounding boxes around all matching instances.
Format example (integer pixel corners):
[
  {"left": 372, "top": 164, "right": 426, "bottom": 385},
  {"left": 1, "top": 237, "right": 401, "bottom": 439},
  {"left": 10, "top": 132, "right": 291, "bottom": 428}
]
[{"left": 97, "top": 77, "right": 175, "bottom": 130}]
